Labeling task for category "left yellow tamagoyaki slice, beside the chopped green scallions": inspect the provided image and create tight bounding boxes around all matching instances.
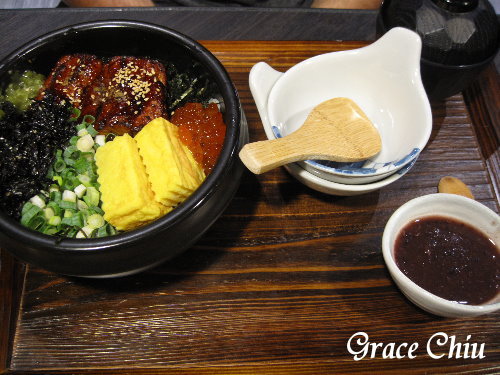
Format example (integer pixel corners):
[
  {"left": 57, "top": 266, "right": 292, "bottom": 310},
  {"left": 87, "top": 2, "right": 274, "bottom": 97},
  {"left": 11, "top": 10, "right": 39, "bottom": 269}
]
[{"left": 95, "top": 134, "right": 171, "bottom": 230}]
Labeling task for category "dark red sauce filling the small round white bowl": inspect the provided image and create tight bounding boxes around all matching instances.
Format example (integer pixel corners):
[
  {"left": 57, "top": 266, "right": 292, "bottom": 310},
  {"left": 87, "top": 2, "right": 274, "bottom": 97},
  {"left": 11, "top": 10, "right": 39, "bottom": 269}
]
[{"left": 394, "top": 216, "right": 500, "bottom": 305}]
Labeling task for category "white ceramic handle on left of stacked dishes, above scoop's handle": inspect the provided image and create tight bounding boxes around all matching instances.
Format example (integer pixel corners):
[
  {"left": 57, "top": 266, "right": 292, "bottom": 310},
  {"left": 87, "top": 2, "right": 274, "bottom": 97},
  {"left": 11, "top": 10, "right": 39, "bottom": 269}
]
[{"left": 248, "top": 62, "right": 283, "bottom": 139}]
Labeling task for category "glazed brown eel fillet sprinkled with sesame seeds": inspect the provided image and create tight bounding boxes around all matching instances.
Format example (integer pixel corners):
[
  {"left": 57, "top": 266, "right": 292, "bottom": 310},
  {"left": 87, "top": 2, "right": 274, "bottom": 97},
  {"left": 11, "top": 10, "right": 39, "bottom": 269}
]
[{"left": 39, "top": 54, "right": 167, "bottom": 135}]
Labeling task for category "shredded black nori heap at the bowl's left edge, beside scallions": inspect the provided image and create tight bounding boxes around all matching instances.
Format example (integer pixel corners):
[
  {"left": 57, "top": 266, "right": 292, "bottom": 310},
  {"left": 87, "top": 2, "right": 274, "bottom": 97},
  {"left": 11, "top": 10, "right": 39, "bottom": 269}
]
[{"left": 0, "top": 95, "right": 75, "bottom": 219}]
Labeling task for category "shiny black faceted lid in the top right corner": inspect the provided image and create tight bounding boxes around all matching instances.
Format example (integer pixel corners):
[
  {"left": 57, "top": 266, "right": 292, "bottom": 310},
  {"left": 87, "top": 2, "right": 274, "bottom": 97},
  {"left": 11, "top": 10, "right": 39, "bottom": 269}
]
[{"left": 380, "top": 0, "right": 500, "bottom": 66}]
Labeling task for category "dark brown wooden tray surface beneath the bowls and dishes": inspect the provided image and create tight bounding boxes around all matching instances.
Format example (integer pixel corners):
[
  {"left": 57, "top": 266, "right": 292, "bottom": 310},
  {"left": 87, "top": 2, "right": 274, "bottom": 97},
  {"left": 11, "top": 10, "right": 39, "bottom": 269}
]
[{"left": 0, "top": 7, "right": 500, "bottom": 374}]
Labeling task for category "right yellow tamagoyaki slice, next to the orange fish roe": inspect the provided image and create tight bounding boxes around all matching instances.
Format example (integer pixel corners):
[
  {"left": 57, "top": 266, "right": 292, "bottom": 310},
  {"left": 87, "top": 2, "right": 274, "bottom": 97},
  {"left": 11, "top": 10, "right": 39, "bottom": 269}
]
[{"left": 135, "top": 117, "right": 201, "bottom": 206}]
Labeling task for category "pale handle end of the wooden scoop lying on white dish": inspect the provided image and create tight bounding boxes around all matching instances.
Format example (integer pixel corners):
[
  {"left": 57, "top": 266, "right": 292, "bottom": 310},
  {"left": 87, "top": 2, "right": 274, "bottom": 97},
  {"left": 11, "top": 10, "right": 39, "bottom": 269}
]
[{"left": 240, "top": 135, "right": 309, "bottom": 174}]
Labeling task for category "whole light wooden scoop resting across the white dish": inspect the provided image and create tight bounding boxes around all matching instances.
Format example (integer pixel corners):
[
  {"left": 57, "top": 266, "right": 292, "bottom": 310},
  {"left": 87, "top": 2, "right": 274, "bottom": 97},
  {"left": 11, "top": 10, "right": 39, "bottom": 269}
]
[{"left": 240, "top": 98, "right": 382, "bottom": 174}]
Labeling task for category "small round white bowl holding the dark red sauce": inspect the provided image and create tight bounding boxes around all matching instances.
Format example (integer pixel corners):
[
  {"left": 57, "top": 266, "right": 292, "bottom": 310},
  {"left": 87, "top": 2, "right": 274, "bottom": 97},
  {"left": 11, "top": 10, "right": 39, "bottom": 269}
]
[{"left": 382, "top": 193, "right": 500, "bottom": 317}]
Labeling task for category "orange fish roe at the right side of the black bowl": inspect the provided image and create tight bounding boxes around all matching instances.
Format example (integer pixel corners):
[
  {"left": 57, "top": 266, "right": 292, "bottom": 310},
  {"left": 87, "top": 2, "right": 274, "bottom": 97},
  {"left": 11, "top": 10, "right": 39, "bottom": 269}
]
[{"left": 170, "top": 103, "right": 226, "bottom": 175}]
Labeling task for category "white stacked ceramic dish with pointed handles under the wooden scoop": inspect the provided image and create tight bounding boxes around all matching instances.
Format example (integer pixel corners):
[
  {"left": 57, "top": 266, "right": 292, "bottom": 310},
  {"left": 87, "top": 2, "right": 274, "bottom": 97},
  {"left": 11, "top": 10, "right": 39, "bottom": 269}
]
[{"left": 249, "top": 28, "right": 432, "bottom": 184}]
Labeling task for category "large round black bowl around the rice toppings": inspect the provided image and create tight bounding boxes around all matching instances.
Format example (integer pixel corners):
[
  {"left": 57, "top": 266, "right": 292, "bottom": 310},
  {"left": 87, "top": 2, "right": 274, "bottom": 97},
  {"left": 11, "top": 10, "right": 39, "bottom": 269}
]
[{"left": 0, "top": 21, "right": 248, "bottom": 277}]
